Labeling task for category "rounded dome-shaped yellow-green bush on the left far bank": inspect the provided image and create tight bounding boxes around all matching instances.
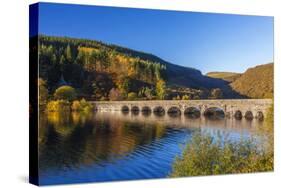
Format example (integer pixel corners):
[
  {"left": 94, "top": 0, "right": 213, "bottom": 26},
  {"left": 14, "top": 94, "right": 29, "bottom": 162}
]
[{"left": 54, "top": 86, "right": 76, "bottom": 101}]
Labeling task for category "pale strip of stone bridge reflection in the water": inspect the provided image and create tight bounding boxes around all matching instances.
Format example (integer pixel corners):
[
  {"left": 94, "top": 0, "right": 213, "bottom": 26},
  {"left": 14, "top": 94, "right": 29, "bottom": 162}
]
[{"left": 95, "top": 111, "right": 264, "bottom": 131}]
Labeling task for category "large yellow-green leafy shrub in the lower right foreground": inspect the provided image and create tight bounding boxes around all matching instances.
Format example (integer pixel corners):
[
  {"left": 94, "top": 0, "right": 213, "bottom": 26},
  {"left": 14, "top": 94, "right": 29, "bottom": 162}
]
[{"left": 171, "top": 131, "right": 273, "bottom": 177}]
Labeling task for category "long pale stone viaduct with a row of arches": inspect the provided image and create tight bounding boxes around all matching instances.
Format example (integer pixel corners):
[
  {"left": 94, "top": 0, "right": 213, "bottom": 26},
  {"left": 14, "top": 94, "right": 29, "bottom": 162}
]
[{"left": 91, "top": 99, "right": 272, "bottom": 119}]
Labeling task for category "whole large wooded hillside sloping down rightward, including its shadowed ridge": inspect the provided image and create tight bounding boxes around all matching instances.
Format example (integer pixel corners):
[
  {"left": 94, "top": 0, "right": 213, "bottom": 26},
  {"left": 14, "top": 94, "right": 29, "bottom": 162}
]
[{"left": 36, "top": 35, "right": 238, "bottom": 100}]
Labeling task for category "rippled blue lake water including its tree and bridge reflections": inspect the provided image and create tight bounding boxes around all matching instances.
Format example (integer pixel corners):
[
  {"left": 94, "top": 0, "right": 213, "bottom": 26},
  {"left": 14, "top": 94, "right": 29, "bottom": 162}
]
[{"left": 39, "top": 112, "right": 263, "bottom": 185}]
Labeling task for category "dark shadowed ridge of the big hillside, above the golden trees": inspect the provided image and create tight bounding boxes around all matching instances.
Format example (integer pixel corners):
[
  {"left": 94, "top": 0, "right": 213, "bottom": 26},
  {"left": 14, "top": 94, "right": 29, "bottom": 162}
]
[{"left": 40, "top": 36, "right": 225, "bottom": 88}]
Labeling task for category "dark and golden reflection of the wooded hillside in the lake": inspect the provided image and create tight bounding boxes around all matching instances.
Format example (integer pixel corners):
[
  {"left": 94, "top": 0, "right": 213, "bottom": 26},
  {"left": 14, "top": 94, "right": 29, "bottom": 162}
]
[{"left": 39, "top": 113, "right": 170, "bottom": 172}]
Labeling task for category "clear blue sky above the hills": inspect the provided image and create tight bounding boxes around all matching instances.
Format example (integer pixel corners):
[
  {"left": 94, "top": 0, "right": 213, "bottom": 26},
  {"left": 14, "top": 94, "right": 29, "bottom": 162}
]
[{"left": 39, "top": 3, "right": 273, "bottom": 73}]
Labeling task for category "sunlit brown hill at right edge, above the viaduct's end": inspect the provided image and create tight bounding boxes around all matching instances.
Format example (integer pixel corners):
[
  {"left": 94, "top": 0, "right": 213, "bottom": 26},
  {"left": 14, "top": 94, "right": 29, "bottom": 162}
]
[{"left": 230, "top": 63, "right": 273, "bottom": 98}]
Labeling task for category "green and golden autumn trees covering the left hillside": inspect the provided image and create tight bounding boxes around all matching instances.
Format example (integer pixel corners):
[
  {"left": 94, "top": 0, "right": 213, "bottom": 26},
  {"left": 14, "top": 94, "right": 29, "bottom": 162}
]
[{"left": 39, "top": 35, "right": 166, "bottom": 100}]
